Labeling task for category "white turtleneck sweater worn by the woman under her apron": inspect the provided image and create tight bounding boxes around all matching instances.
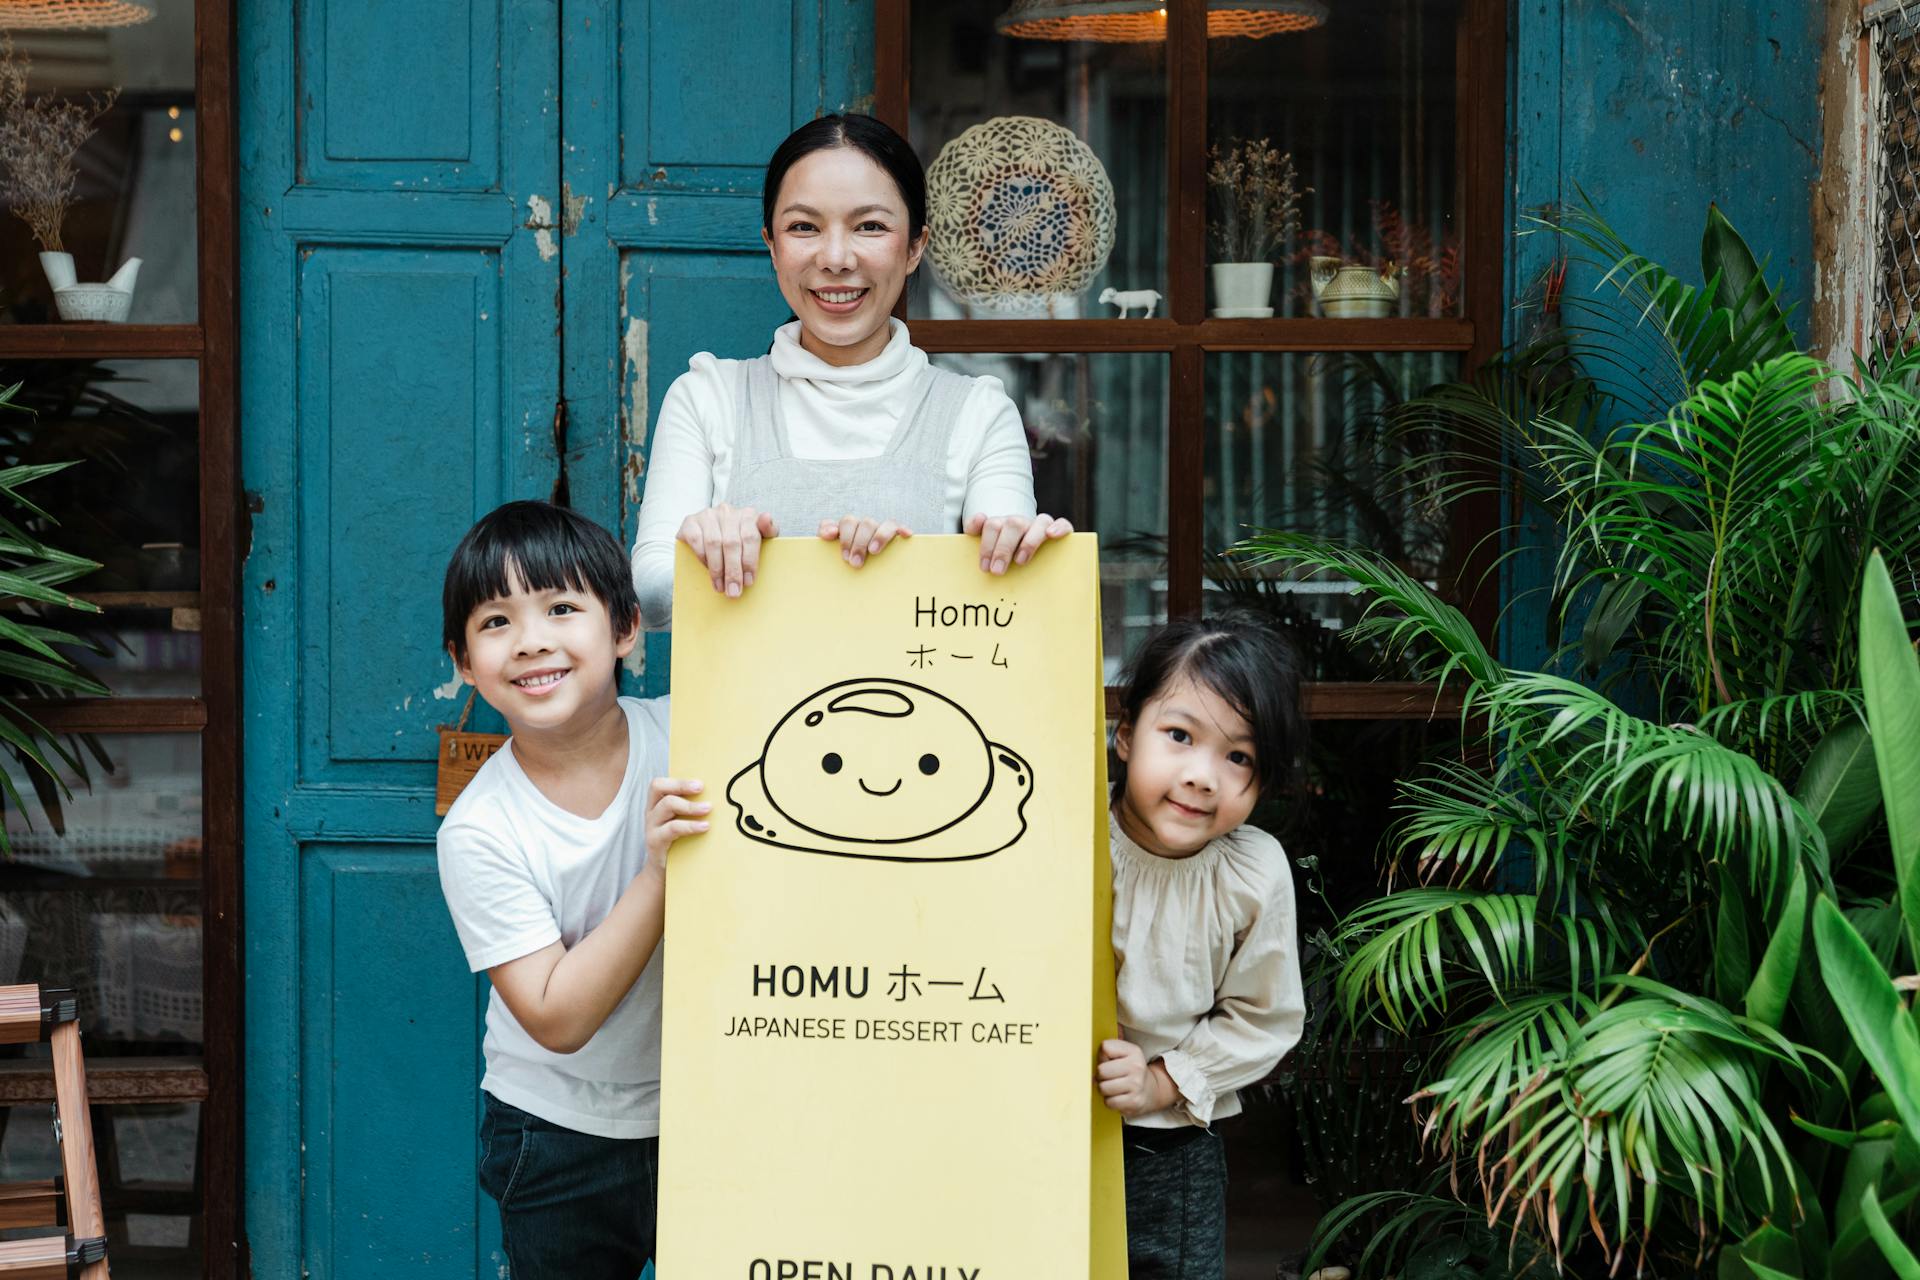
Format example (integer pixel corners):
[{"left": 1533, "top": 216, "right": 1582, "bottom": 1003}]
[{"left": 634, "top": 320, "right": 1035, "bottom": 629}]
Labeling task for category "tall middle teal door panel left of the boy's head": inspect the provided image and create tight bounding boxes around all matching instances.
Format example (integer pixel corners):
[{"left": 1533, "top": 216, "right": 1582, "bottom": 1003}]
[{"left": 298, "top": 248, "right": 503, "bottom": 787}]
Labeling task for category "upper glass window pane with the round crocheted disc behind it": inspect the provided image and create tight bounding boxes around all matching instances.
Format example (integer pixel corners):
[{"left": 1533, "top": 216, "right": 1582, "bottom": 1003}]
[{"left": 908, "top": 0, "right": 1167, "bottom": 319}]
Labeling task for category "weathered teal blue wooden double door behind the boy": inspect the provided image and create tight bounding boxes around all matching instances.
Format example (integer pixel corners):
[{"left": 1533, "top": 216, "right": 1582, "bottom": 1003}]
[{"left": 238, "top": 0, "right": 872, "bottom": 1280}]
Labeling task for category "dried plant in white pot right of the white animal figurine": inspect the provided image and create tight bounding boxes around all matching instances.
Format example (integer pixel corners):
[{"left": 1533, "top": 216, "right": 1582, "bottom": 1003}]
[{"left": 1206, "top": 138, "right": 1311, "bottom": 319}]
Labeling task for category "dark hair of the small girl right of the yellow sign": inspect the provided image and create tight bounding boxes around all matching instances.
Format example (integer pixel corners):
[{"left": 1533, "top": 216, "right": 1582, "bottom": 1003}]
[{"left": 1112, "top": 610, "right": 1308, "bottom": 800}]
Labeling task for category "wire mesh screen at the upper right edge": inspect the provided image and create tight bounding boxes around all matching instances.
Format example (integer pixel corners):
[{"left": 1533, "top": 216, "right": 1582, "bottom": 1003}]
[{"left": 1866, "top": 0, "right": 1920, "bottom": 347}]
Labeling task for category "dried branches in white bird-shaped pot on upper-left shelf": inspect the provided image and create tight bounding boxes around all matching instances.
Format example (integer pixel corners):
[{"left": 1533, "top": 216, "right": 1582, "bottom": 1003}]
[{"left": 0, "top": 33, "right": 140, "bottom": 320}]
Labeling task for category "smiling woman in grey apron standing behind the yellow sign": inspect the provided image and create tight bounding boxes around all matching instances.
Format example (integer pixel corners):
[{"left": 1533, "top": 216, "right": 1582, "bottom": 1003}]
[{"left": 634, "top": 115, "right": 1073, "bottom": 628}]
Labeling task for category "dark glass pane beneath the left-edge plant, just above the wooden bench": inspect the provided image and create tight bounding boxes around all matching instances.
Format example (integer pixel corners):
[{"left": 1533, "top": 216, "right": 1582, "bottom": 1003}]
[{"left": 0, "top": 733, "right": 202, "bottom": 1055}]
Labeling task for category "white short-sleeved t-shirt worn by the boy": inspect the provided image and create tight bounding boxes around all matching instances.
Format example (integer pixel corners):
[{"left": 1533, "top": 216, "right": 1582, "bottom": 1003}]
[{"left": 438, "top": 699, "right": 668, "bottom": 1138}]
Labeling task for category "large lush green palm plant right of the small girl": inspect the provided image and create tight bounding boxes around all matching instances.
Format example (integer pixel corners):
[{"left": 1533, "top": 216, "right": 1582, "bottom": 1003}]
[{"left": 1240, "top": 203, "right": 1920, "bottom": 1278}]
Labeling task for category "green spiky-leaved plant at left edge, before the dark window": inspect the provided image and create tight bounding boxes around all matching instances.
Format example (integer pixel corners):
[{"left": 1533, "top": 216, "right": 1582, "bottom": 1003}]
[{"left": 0, "top": 382, "right": 111, "bottom": 856}]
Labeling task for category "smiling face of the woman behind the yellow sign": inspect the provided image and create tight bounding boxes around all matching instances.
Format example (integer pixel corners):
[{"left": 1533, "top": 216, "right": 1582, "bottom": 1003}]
[{"left": 760, "top": 146, "right": 927, "bottom": 365}]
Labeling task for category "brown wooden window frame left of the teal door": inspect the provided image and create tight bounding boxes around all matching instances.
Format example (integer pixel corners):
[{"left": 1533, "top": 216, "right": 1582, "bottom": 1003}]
[{"left": 0, "top": 0, "right": 246, "bottom": 1280}]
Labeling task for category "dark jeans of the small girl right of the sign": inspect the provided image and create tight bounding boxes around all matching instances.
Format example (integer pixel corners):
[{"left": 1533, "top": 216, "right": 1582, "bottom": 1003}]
[{"left": 1125, "top": 1126, "right": 1227, "bottom": 1280}]
